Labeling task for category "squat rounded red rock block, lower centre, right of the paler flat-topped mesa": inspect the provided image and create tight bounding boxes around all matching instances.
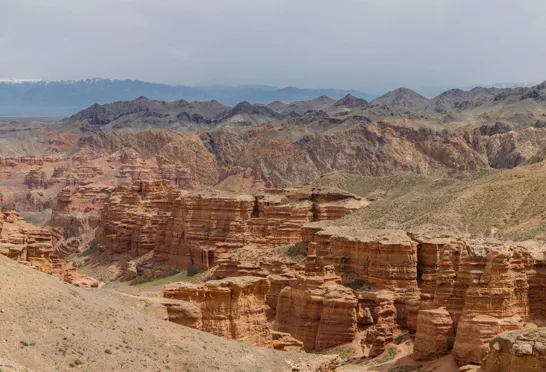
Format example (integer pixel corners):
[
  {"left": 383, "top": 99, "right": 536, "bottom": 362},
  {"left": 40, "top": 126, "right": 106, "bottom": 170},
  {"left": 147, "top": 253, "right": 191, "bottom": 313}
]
[{"left": 275, "top": 265, "right": 358, "bottom": 351}]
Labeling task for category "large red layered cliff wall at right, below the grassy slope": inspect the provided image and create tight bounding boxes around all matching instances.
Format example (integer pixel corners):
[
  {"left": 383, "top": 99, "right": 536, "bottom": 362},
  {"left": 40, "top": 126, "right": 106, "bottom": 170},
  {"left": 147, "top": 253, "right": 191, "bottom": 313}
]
[{"left": 300, "top": 223, "right": 546, "bottom": 365}]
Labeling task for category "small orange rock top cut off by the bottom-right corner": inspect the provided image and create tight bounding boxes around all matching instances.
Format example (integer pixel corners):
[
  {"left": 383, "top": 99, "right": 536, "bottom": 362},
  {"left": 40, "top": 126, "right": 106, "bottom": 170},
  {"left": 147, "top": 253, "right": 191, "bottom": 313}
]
[{"left": 479, "top": 328, "right": 546, "bottom": 372}]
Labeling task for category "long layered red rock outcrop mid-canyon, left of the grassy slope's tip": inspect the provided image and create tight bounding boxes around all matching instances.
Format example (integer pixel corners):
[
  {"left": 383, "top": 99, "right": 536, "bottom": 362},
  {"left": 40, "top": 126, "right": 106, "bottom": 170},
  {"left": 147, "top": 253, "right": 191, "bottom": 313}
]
[{"left": 102, "top": 185, "right": 367, "bottom": 270}]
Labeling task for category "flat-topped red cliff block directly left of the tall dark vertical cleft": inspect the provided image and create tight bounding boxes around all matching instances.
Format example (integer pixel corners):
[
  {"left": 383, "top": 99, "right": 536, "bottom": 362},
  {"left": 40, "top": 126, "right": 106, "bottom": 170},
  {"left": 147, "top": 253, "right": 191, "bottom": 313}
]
[{"left": 303, "top": 224, "right": 419, "bottom": 298}]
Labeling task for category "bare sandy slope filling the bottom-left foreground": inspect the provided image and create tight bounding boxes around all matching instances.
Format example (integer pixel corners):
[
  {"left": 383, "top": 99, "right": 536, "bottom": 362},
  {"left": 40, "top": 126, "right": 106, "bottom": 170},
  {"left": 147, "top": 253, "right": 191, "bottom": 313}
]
[{"left": 0, "top": 256, "right": 333, "bottom": 372}]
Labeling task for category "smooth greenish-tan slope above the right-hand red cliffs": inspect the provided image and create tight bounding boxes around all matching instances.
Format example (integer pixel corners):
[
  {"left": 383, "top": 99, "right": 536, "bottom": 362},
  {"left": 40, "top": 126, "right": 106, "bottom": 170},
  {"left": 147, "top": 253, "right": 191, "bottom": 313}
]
[{"left": 319, "top": 162, "right": 546, "bottom": 240}]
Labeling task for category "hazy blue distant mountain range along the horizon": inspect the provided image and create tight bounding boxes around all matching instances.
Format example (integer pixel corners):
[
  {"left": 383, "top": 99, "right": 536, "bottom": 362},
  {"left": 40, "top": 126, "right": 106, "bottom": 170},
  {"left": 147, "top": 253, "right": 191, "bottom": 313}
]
[{"left": 0, "top": 78, "right": 529, "bottom": 117}]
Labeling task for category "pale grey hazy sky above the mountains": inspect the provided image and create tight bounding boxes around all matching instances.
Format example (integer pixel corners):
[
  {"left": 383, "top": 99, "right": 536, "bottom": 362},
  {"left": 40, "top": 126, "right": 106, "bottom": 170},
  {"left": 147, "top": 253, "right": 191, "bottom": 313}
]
[{"left": 0, "top": 0, "right": 546, "bottom": 92}]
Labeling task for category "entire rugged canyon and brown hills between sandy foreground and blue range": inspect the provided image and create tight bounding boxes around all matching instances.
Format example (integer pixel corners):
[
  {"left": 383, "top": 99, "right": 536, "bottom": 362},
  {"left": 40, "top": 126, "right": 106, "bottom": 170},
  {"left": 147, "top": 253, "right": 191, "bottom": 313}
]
[{"left": 5, "top": 87, "right": 546, "bottom": 372}]
